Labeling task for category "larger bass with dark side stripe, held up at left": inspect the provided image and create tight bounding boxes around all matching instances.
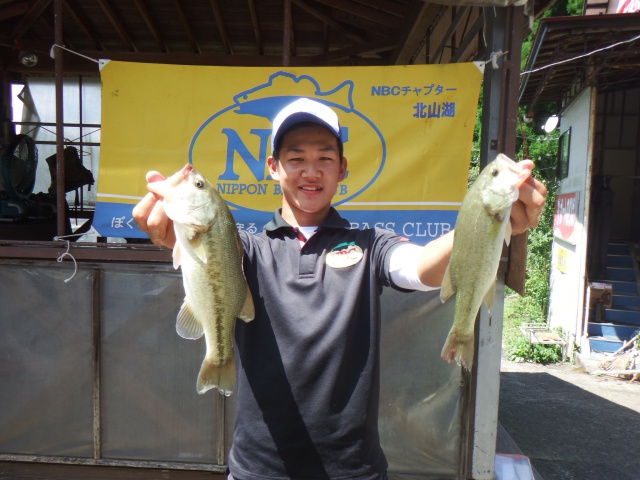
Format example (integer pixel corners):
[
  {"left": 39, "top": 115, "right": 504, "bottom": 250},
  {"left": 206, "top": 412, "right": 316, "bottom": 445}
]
[{"left": 147, "top": 164, "right": 255, "bottom": 396}]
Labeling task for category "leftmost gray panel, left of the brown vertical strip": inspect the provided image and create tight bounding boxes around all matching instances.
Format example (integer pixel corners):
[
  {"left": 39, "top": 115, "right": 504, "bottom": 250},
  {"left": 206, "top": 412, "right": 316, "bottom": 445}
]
[{"left": 0, "top": 265, "right": 93, "bottom": 457}]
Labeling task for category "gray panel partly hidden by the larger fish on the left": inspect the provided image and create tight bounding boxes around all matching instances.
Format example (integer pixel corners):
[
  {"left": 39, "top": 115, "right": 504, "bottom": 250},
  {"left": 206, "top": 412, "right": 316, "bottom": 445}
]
[{"left": 101, "top": 268, "right": 224, "bottom": 463}]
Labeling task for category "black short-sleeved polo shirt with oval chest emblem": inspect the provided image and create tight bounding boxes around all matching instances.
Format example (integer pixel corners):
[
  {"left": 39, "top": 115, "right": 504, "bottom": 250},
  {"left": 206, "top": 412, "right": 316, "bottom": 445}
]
[{"left": 229, "top": 209, "right": 407, "bottom": 480}]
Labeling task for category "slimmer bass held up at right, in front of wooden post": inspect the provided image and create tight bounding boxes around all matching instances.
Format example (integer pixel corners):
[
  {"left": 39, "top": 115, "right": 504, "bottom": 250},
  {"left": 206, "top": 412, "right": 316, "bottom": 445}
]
[{"left": 440, "top": 154, "right": 531, "bottom": 370}]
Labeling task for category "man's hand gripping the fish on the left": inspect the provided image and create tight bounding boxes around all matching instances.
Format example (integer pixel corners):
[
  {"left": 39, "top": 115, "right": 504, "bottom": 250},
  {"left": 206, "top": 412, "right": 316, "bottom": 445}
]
[{"left": 132, "top": 171, "right": 176, "bottom": 248}]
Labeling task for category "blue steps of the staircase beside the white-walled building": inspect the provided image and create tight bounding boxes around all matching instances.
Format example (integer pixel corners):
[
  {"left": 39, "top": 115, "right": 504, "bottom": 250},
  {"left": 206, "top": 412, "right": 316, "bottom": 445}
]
[{"left": 587, "top": 243, "right": 640, "bottom": 352}]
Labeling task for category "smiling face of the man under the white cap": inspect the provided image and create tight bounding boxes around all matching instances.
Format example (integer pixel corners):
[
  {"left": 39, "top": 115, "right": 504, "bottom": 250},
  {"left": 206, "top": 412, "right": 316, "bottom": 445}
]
[{"left": 268, "top": 124, "right": 347, "bottom": 226}]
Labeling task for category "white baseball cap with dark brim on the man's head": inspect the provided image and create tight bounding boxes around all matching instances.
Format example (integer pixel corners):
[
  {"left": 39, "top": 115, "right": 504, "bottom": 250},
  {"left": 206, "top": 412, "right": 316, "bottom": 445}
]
[{"left": 271, "top": 98, "right": 342, "bottom": 151}]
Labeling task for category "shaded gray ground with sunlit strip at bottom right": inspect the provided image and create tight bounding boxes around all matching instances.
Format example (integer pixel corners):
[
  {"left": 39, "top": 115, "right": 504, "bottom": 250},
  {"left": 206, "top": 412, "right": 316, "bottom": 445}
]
[{"left": 499, "top": 359, "right": 640, "bottom": 480}]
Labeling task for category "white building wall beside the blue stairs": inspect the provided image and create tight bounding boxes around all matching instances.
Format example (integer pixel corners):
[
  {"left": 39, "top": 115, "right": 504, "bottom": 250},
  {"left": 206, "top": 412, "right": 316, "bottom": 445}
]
[{"left": 549, "top": 89, "right": 592, "bottom": 348}]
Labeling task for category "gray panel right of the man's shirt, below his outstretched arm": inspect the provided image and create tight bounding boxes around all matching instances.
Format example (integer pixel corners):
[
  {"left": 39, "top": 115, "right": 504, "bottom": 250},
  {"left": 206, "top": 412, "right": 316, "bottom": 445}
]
[{"left": 379, "top": 289, "right": 464, "bottom": 479}]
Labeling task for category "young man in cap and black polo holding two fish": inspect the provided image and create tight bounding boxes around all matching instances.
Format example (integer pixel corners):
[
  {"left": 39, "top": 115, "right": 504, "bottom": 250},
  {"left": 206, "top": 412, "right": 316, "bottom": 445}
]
[{"left": 134, "top": 99, "right": 546, "bottom": 480}]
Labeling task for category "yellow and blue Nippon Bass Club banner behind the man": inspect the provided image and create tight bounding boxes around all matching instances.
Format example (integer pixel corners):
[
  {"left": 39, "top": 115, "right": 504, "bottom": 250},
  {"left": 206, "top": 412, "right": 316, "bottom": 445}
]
[{"left": 93, "top": 62, "right": 482, "bottom": 243}]
